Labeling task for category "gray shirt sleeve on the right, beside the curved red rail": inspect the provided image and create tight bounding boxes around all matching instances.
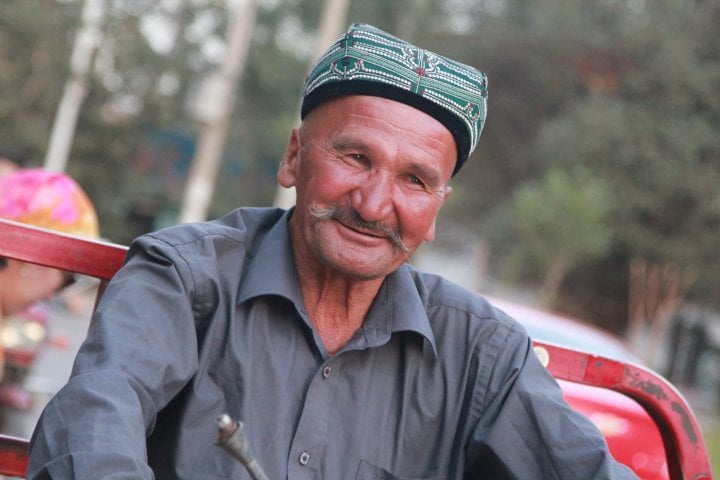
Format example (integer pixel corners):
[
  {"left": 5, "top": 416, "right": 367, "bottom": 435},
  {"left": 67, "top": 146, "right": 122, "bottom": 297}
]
[{"left": 465, "top": 325, "right": 637, "bottom": 480}]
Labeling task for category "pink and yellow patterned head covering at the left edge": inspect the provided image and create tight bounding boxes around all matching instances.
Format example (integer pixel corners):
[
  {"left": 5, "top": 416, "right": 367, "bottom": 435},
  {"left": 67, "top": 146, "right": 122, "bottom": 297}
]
[{"left": 0, "top": 168, "right": 99, "bottom": 237}]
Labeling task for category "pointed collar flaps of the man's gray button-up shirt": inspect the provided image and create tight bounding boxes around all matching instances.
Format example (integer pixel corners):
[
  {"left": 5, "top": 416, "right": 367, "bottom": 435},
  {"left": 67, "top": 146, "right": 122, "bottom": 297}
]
[{"left": 238, "top": 210, "right": 437, "bottom": 355}]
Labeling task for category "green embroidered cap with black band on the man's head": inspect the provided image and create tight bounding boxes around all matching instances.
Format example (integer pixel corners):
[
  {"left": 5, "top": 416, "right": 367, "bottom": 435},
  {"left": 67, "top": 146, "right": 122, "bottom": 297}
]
[{"left": 300, "top": 23, "right": 487, "bottom": 175}]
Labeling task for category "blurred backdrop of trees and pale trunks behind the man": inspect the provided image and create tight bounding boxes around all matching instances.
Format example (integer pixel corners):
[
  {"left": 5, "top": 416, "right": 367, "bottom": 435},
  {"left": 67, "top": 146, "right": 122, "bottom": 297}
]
[{"left": 0, "top": 0, "right": 720, "bottom": 472}]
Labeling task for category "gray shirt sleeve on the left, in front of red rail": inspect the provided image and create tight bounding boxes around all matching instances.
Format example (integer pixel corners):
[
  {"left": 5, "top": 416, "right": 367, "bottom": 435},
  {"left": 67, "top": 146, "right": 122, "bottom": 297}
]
[{"left": 27, "top": 237, "right": 198, "bottom": 479}]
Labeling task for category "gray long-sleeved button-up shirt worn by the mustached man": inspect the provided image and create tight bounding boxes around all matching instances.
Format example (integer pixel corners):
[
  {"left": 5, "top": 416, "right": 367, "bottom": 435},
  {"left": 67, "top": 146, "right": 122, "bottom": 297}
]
[{"left": 29, "top": 209, "right": 634, "bottom": 480}]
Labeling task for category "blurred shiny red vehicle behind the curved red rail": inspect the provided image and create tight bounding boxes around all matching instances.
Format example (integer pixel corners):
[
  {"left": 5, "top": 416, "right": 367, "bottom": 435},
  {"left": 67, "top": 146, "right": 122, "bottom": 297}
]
[{"left": 489, "top": 298, "right": 670, "bottom": 480}]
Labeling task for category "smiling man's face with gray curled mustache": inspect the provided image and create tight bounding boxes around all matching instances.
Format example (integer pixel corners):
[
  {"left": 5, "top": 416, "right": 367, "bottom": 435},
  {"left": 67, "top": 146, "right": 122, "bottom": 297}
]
[{"left": 278, "top": 96, "right": 457, "bottom": 280}]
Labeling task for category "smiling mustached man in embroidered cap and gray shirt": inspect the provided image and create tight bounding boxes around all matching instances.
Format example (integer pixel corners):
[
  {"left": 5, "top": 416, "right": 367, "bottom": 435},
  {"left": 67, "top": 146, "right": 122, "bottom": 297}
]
[{"left": 29, "top": 25, "right": 634, "bottom": 480}]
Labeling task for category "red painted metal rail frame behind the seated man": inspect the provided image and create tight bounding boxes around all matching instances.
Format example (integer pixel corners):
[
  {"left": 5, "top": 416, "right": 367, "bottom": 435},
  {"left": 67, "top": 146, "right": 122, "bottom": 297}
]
[{"left": 0, "top": 219, "right": 712, "bottom": 480}]
